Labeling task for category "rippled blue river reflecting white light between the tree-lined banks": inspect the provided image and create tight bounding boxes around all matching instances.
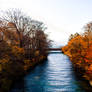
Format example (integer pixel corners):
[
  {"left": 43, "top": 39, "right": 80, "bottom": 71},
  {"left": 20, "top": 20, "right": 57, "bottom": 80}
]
[{"left": 11, "top": 53, "right": 85, "bottom": 92}]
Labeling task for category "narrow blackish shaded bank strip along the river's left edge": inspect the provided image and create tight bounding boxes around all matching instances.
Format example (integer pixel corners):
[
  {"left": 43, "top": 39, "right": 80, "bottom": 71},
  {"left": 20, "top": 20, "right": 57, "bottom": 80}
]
[{"left": 9, "top": 55, "right": 47, "bottom": 92}]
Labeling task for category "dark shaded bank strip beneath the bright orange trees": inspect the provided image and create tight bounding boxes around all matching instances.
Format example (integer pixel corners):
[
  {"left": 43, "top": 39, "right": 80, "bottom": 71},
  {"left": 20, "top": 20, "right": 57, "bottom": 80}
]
[{"left": 62, "top": 52, "right": 92, "bottom": 92}]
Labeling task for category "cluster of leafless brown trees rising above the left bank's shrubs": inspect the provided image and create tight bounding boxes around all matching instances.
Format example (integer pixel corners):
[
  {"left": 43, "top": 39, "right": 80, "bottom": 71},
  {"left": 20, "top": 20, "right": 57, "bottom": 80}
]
[{"left": 1, "top": 9, "right": 49, "bottom": 57}]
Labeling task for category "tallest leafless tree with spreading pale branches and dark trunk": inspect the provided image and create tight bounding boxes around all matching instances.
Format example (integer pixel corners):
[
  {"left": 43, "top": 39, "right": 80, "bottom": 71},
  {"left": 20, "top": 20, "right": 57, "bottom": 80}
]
[{"left": 1, "top": 9, "right": 33, "bottom": 47}]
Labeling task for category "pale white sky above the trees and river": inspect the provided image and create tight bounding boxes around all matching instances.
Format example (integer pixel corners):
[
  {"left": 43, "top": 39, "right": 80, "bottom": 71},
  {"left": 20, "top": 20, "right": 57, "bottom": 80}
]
[{"left": 0, "top": 0, "right": 92, "bottom": 45}]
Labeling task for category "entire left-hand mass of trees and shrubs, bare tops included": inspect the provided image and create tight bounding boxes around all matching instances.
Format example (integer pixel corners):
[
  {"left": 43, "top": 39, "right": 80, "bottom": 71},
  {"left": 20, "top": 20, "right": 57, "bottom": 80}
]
[{"left": 0, "top": 9, "right": 50, "bottom": 92}]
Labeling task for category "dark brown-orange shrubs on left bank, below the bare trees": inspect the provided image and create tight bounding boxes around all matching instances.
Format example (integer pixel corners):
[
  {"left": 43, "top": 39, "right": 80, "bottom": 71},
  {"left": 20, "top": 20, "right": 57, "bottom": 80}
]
[{"left": 0, "top": 41, "right": 48, "bottom": 92}]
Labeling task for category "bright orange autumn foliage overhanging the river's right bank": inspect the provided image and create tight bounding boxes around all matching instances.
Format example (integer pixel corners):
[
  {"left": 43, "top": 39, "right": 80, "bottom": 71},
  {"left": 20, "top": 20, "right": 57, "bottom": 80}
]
[{"left": 62, "top": 29, "right": 92, "bottom": 86}]
